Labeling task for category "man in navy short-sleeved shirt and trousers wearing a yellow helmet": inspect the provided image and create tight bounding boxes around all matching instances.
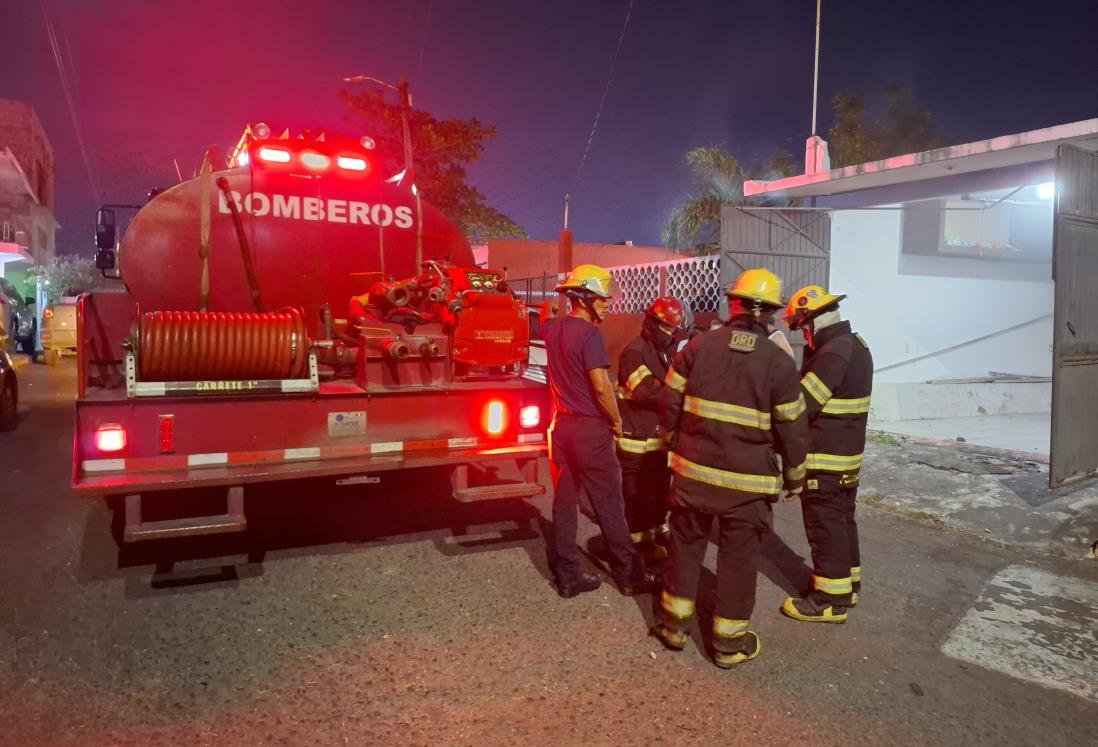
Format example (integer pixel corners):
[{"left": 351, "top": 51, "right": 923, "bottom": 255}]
[{"left": 541, "top": 265, "right": 660, "bottom": 598}]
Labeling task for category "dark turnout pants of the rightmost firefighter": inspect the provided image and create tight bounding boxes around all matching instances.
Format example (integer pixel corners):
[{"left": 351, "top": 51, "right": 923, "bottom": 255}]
[{"left": 800, "top": 473, "right": 862, "bottom": 606}]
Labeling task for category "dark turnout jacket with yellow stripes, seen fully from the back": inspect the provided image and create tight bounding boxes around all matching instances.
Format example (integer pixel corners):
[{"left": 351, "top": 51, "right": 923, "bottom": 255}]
[{"left": 663, "top": 317, "right": 808, "bottom": 515}]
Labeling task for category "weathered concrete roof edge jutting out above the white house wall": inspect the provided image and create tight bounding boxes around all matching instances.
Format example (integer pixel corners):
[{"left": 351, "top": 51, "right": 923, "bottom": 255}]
[{"left": 743, "top": 119, "right": 1098, "bottom": 199}]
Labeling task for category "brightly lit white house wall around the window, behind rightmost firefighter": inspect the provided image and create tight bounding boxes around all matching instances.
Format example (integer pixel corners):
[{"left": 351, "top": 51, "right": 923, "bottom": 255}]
[{"left": 825, "top": 210, "right": 1053, "bottom": 388}]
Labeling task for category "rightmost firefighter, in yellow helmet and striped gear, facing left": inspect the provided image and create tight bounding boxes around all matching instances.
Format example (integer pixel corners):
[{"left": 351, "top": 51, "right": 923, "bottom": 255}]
[{"left": 782, "top": 286, "right": 873, "bottom": 623}]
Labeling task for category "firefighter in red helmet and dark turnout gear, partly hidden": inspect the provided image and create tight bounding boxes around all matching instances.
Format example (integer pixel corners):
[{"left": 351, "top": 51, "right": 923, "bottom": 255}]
[{"left": 617, "top": 296, "right": 686, "bottom": 560}]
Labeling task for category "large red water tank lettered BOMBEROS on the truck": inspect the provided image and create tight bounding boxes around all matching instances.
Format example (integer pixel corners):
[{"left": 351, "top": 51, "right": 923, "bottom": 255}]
[{"left": 120, "top": 141, "right": 473, "bottom": 335}]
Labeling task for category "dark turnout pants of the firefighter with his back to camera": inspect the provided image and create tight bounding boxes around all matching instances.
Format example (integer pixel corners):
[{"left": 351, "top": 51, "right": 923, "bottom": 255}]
[{"left": 660, "top": 498, "right": 773, "bottom": 654}]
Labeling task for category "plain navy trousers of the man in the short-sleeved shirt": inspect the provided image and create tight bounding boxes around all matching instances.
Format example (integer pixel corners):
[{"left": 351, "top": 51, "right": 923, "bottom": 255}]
[{"left": 549, "top": 414, "right": 645, "bottom": 586}]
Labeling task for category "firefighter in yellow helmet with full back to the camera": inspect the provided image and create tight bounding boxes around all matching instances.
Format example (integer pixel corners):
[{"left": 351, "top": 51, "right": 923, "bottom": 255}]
[{"left": 653, "top": 269, "right": 808, "bottom": 667}]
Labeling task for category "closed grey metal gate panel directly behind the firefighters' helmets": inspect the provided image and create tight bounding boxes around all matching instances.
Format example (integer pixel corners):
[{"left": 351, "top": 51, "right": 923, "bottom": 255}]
[{"left": 720, "top": 205, "right": 831, "bottom": 314}]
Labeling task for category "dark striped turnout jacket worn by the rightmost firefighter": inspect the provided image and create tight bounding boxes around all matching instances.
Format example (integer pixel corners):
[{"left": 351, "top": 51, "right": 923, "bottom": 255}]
[{"left": 800, "top": 322, "right": 873, "bottom": 475}]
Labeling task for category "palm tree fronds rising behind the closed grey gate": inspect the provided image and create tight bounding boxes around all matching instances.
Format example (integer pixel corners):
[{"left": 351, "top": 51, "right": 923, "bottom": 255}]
[{"left": 662, "top": 145, "right": 799, "bottom": 255}]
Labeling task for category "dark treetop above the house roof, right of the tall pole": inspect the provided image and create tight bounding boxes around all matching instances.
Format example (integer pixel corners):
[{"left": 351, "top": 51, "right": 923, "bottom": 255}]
[{"left": 828, "top": 83, "right": 948, "bottom": 168}]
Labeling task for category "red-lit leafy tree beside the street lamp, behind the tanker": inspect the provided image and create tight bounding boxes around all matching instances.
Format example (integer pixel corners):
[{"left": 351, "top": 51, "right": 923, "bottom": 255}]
[{"left": 340, "top": 90, "right": 526, "bottom": 242}]
